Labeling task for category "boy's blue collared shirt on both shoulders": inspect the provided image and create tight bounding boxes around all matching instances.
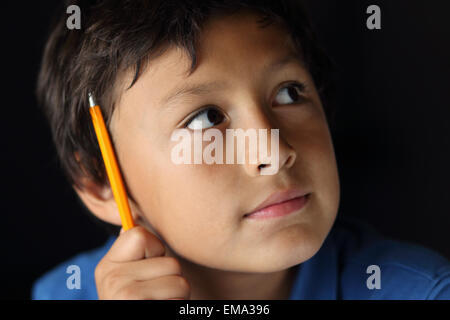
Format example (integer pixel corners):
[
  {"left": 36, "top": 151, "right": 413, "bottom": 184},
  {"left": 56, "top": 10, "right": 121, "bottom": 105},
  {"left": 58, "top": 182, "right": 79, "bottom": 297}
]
[{"left": 32, "top": 219, "right": 450, "bottom": 300}]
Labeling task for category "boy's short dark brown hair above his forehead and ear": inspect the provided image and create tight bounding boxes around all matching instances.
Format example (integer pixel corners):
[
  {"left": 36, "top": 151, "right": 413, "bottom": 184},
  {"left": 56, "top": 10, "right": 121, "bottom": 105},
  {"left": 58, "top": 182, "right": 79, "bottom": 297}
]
[{"left": 37, "top": 0, "right": 330, "bottom": 192}]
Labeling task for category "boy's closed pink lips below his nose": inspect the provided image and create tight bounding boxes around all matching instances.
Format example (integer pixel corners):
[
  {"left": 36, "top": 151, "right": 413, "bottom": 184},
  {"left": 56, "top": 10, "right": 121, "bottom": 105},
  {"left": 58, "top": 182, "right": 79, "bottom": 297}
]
[{"left": 244, "top": 188, "right": 310, "bottom": 218}]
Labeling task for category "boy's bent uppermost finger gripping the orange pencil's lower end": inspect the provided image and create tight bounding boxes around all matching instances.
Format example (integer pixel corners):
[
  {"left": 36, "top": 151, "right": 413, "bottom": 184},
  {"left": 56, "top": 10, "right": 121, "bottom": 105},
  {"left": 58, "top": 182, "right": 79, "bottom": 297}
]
[{"left": 104, "top": 226, "right": 165, "bottom": 262}]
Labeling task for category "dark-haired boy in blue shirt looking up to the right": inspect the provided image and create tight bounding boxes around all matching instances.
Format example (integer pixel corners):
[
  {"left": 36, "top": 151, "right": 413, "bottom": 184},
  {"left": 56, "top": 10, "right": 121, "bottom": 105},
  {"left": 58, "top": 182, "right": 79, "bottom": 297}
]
[{"left": 33, "top": 0, "right": 450, "bottom": 299}]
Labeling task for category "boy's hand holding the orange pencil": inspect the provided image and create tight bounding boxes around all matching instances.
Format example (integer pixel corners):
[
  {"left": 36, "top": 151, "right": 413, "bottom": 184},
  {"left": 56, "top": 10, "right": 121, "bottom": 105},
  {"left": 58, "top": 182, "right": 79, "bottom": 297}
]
[{"left": 95, "top": 226, "right": 191, "bottom": 300}]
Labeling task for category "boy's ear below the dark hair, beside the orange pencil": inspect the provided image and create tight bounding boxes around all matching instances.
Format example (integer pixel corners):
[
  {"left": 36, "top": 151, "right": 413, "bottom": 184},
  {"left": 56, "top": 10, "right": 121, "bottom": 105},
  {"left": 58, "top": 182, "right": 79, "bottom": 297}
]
[{"left": 73, "top": 178, "right": 121, "bottom": 225}]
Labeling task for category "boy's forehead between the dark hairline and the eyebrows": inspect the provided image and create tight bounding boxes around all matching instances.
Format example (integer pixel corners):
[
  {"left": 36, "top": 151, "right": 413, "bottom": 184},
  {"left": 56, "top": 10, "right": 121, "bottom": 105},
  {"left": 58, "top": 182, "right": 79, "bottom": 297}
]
[{"left": 119, "top": 11, "right": 301, "bottom": 107}]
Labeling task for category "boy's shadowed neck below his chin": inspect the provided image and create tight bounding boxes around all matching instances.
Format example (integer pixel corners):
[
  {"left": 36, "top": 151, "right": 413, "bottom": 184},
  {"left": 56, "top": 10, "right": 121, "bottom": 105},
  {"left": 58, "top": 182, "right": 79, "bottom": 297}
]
[{"left": 167, "top": 251, "right": 297, "bottom": 300}]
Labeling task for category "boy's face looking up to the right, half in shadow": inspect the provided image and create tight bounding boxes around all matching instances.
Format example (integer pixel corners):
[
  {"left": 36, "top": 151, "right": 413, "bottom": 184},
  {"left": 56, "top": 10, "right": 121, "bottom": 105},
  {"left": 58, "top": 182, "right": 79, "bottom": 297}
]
[{"left": 111, "top": 12, "right": 339, "bottom": 272}]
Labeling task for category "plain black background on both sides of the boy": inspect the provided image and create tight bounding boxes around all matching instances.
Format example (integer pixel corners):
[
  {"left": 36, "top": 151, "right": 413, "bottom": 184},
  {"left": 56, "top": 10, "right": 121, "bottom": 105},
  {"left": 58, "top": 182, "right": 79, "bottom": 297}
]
[{"left": 0, "top": 0, "right": 450, "bottom": 299}]
